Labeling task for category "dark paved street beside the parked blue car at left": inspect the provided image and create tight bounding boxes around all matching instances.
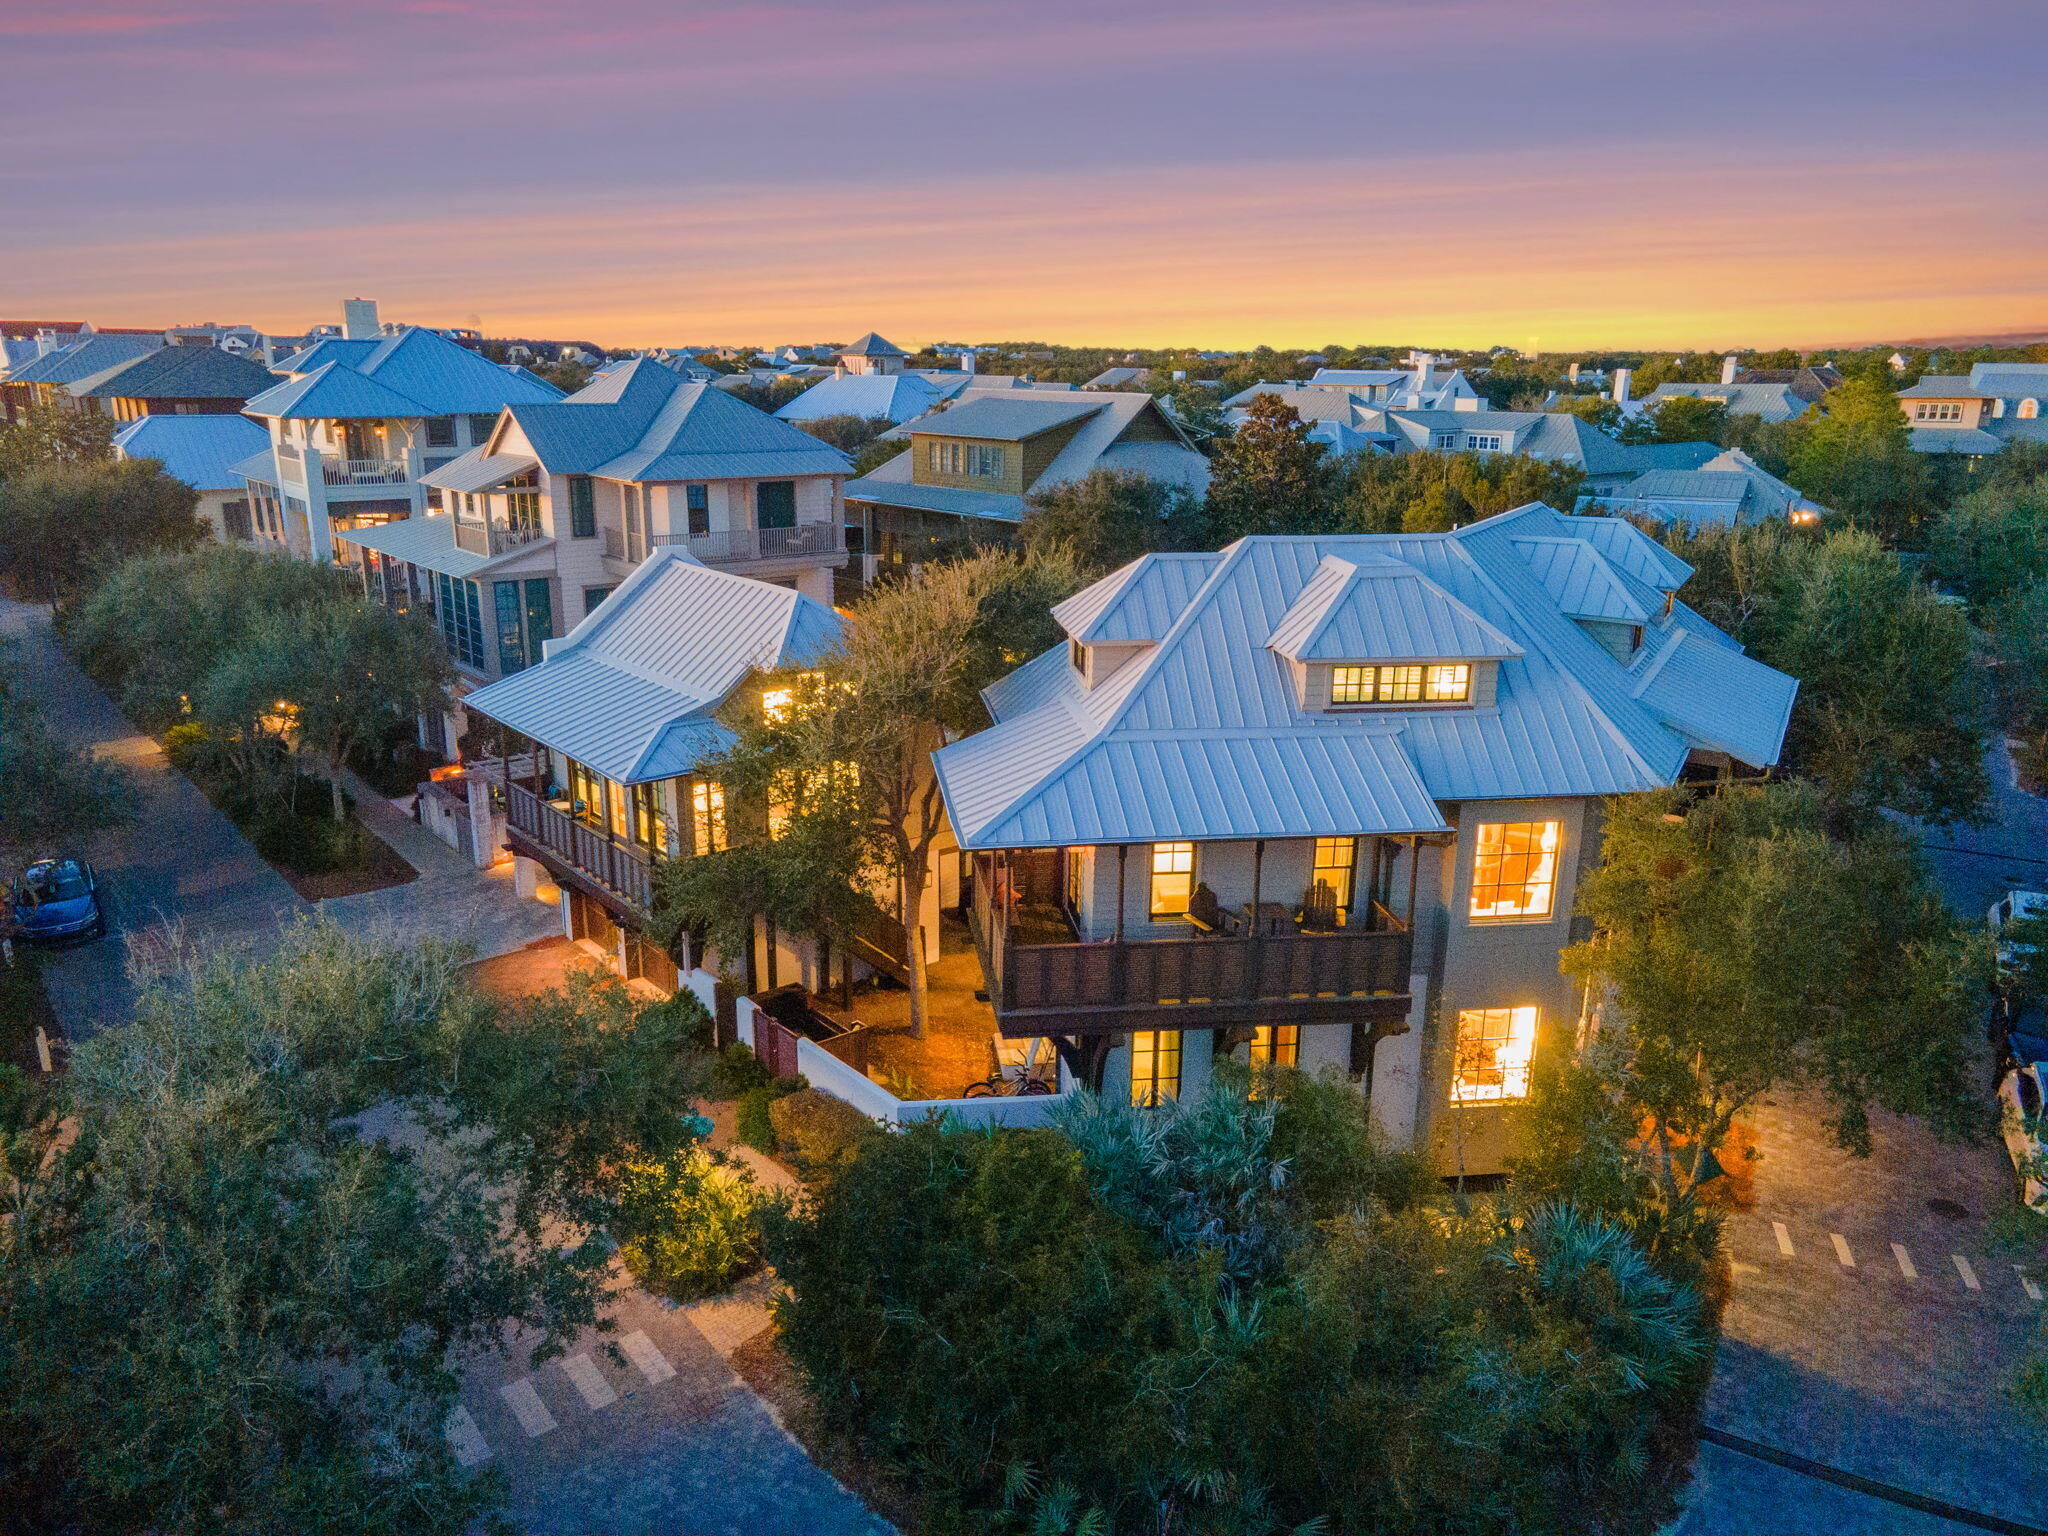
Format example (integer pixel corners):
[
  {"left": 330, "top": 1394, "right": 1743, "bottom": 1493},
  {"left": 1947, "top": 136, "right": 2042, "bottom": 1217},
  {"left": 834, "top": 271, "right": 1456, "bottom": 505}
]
[{"left": 0, "top": 598, "right": 309, "bottom": 1040}]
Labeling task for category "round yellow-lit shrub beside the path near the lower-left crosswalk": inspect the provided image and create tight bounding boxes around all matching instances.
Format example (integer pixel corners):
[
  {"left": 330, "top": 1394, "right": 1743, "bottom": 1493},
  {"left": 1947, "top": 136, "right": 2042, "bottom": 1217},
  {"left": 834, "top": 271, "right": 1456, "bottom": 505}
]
[{"left": 618, "top": 1147, "right": 768, "bottom": 1300}]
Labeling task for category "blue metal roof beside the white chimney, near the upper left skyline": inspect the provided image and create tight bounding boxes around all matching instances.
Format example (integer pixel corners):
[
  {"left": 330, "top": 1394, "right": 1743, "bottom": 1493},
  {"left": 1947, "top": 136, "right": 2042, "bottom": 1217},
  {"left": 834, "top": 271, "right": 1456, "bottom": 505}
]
[{"left": 248, "top": 326, "right": 561, "bottom": 420}]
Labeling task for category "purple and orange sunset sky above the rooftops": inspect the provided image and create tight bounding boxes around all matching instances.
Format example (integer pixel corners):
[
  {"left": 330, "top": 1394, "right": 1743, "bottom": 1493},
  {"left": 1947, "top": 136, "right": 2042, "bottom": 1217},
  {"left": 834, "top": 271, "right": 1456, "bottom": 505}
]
[{"left": 0, "top": 0, "right": 2048, "bottom": 350}]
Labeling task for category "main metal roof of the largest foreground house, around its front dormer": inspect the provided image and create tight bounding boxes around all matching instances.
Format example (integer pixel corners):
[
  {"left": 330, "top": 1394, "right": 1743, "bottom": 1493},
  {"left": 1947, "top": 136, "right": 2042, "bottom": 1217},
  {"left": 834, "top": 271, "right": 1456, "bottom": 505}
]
[{"left": 934, "top": 504, "right": 1790, "bottom": 848}]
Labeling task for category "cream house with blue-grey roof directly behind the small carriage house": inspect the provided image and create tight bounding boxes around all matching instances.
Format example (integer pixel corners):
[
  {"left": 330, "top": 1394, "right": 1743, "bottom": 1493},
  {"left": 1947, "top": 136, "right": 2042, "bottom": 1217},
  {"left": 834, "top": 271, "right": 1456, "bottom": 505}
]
[{"left": 336, "top": 358, "right": 852, "bottom": 704}]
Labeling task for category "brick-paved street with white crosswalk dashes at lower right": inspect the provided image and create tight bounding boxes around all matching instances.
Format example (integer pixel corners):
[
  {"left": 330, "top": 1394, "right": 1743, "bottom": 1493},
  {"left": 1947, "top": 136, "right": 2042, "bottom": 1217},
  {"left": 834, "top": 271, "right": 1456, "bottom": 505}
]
[{"left": 1675, "top": 1100, "right": 2048, "bottom": 1536}]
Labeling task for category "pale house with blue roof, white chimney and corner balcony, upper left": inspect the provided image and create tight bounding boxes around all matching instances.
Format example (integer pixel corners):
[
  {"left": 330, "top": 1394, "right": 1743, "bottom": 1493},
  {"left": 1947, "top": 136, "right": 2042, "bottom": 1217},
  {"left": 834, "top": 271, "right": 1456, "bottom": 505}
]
[{"left": 242, "top": 299, "right": 561, "bottom": 559}]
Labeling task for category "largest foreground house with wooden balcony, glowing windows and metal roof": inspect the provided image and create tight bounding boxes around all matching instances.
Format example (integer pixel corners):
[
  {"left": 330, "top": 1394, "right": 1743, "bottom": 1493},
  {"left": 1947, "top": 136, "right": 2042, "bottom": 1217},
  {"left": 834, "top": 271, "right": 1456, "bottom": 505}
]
[{"left": 934, "top": 499, "right": 1796, "bottom": 1174}]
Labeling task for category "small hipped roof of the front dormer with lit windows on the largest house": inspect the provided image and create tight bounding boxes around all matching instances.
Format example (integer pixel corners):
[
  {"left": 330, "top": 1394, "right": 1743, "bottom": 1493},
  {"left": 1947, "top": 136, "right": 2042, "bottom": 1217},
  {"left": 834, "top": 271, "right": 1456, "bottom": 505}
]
[{"left": 1266, "top": 553, "right": 1522, "bottom": 662}]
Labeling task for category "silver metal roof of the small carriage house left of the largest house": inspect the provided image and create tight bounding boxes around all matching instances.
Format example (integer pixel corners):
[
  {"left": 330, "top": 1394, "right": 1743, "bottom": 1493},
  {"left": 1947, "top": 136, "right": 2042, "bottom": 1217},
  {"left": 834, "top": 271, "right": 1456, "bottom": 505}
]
[{"left": 463, "top": 545, "right": 840, "bottom": 784}]
